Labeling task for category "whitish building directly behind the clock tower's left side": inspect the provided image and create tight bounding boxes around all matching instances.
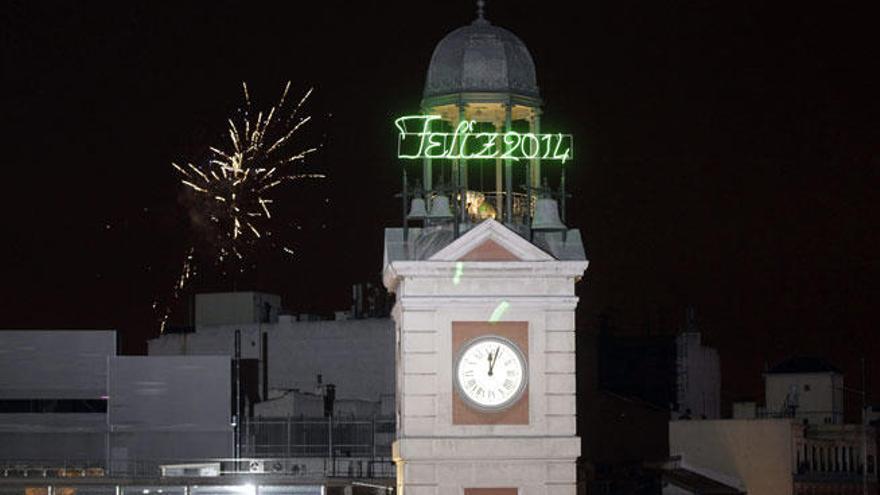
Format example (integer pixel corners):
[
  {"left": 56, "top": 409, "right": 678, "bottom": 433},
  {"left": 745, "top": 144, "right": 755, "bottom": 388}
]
[{"left": 148, "top": 292, "right": 394, "bottom": 464}]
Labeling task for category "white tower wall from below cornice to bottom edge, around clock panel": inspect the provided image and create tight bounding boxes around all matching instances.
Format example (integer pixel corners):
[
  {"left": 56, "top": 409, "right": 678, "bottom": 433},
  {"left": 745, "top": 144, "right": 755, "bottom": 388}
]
[{"left": 394, "top": 294, "right": 580, "bottom": 495}]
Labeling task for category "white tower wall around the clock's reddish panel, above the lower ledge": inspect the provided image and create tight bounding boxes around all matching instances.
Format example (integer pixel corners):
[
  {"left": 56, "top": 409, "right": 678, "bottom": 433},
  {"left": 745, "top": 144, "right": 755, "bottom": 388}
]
[{"left": 400, "top": 300, "right": 575, "bottom": 437}]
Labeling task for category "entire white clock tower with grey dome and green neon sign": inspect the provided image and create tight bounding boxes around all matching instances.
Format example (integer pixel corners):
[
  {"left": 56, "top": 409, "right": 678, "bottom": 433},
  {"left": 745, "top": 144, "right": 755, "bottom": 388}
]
[{"left": 383, "top": 5, "right": 587, "bottom": 495}]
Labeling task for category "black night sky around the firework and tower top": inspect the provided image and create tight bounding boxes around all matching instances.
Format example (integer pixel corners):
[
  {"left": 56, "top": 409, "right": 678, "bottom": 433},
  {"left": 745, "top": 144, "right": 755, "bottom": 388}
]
[{"left": 0, "top": 0, "right": 880, "bottom": 410}]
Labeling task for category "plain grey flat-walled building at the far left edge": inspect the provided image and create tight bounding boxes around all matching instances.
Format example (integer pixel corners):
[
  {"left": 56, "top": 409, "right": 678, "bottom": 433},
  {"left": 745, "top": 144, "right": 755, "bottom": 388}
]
[{"left": 0, "top": 330, "right": 232, "bottom": 475}]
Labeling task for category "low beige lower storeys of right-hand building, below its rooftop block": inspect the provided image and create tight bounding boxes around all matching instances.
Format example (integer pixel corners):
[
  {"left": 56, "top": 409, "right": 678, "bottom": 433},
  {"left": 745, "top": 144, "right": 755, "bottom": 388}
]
[{"left": 669, "top": 418, "right": 877, "bottom": 495}]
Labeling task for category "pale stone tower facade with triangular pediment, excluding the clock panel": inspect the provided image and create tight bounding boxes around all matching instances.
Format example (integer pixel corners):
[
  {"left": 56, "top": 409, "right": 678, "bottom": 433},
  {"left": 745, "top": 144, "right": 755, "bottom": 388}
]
[{"left": 384, "top": 220, "right": 587, "bottom": 495}]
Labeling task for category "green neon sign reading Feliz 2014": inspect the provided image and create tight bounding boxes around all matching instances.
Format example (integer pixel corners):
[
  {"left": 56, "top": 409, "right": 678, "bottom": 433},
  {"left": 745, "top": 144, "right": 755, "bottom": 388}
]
[{"left": 394, "top": 115, "right": 573, "bottom": 163}]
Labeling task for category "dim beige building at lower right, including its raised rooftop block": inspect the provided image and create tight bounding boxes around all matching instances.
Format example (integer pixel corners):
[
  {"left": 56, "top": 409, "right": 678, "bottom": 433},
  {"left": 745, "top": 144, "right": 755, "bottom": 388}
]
[{"left": 669, "top": 357, "right": 877, "bottom": 495}]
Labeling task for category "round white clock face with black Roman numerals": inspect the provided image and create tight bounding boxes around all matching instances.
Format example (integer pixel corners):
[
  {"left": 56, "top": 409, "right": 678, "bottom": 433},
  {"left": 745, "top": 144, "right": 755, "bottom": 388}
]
[{"left": 455, "top": 335, "right": 528, "bottom": 410}]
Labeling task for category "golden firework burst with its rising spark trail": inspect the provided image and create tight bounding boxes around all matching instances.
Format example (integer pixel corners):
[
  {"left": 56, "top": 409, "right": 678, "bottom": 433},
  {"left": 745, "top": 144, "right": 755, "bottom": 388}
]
[{"left": 154, "top": 81, "right": 324, "bottom": 332}]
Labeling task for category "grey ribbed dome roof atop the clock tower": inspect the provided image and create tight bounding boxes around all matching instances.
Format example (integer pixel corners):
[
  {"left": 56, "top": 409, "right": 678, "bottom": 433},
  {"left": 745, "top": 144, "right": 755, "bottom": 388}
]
[{"left": 423, "top": 17, "right": 540, "bottom": 103}]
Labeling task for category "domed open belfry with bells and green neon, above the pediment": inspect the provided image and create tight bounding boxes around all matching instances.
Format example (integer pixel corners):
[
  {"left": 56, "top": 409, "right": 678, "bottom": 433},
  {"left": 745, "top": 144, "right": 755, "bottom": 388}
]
[{"left": 395, "top": 0, "right": 572, "bottom": 238}]
